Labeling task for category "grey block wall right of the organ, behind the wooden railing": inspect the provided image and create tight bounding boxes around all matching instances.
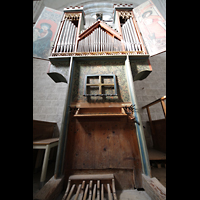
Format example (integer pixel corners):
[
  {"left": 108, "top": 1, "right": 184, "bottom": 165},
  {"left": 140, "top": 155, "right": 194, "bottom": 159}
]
[{"left": 134, "top": 53, "right": 166, "bottom": 147}]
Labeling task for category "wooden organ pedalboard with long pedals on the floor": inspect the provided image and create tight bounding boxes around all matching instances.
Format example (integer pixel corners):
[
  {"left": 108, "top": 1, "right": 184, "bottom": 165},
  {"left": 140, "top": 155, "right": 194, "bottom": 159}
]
[{"left": 62, "top": 174, "right": 117, "bottom": 200}]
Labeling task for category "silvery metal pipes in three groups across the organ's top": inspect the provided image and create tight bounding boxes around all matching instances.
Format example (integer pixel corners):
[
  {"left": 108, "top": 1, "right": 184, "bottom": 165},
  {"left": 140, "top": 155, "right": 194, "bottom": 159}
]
[{"left": 55, "top": 17, "right": 142, "bottom": 52}]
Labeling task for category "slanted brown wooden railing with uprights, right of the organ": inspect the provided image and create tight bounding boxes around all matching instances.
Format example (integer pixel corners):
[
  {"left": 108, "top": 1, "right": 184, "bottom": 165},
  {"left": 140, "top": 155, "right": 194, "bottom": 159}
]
[{"left": 142, "top": 96, "right": 166, "bottom": 134}]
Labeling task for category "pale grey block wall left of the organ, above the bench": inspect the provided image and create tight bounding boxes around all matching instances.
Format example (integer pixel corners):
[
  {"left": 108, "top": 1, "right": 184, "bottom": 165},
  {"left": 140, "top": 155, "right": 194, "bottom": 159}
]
[{"left": 33, "top": 58, "right": 68, "bottom": 131}]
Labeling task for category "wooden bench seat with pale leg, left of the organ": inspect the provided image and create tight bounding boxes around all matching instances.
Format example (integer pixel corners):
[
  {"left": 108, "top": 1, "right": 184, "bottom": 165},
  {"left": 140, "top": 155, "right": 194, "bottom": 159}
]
[{"left": 33, "top": 138, "right": 59, "bottom": 188}]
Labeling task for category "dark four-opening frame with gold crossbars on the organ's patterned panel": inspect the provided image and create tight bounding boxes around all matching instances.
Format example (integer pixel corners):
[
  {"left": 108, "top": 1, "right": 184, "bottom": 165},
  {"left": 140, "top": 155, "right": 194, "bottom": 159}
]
[{"left": 83, "top": 74, "right": 117, "bottom": 96}]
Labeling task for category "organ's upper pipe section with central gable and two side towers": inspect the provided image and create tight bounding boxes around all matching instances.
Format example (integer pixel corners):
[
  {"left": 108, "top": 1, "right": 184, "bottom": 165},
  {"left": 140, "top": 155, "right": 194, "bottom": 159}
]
[{"left": 51, "top": 5, "right": 147, "bottom": 56}]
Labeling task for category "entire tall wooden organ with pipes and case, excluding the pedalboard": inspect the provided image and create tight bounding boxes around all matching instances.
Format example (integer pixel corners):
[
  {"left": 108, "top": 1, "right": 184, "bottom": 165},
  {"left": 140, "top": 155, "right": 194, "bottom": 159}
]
[{"left": 36, "top": 1, "right": 165, "bottom": 199}]
